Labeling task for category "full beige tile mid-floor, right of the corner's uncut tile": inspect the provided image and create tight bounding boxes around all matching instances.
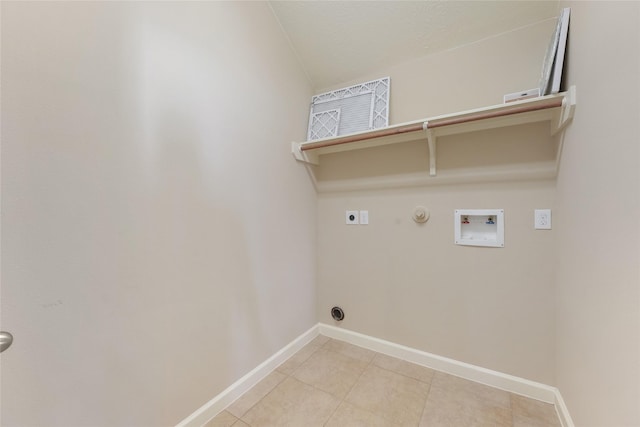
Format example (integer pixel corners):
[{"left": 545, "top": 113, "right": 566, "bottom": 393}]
[{"left": 345, "top": 365, "right": 429, "bottom": 425}]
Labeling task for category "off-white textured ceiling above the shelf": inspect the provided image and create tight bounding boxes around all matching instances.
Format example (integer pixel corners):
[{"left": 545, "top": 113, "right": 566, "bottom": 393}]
[{"left": 269, "top": 0, "right": 559, "bottom": 89}]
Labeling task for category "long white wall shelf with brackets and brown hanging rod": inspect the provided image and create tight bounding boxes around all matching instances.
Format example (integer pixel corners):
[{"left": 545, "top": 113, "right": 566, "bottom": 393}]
[{"left": 291, "top": 86, "right": 576, "bottom": 176}]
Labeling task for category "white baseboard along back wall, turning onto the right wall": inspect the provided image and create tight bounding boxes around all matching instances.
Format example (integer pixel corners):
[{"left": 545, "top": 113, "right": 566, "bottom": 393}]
[{"left": 318, "top": 323, "right": 574, "bottom": 427}]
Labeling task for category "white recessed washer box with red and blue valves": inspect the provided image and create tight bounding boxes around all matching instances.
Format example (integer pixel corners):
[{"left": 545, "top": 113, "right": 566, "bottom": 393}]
[{"left": 454, "top": 209, "right": 504, "bottom": 248}]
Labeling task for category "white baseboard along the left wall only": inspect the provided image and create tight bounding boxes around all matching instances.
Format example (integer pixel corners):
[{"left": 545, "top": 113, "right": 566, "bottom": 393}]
[{"left": 176, "top": 325, "right": 320, "bottom": 427}]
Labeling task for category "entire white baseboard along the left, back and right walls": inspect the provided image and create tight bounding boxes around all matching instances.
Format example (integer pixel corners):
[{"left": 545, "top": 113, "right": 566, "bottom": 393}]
[{"left": 177, "top": 323, "right": 574, "bottom": 427}]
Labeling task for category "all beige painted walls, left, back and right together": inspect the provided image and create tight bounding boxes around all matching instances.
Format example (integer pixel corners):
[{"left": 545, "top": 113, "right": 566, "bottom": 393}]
[{"left": 1, "top": 2, "right": 640, "bottom": 426}]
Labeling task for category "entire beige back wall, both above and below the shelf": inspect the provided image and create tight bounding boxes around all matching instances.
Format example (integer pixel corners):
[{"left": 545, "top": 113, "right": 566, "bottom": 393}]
[{"left": 316, "top": 21, "right": 556, "bottom": 384}]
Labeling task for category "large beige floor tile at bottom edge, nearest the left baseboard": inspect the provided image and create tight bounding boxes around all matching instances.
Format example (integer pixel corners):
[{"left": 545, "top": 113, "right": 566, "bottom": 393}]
[{"left": 242, "top": 377, "right": 340, "bottom": 427}]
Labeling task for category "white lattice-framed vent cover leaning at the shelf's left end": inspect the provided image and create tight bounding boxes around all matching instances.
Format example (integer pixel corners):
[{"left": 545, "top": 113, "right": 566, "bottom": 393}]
[{"left": 307, "top": 77, "right": 390, "bottom": 141}]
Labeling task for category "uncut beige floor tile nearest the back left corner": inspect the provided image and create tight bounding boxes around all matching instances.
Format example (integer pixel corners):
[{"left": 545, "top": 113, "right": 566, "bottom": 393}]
[{"left": 293, "top": 348, "right": 368, "bottom": 399}]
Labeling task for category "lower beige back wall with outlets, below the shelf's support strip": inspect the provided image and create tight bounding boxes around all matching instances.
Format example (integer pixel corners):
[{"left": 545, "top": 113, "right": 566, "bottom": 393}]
[{"left": 318, "top": 182, "right": 554, "bottom": 383}]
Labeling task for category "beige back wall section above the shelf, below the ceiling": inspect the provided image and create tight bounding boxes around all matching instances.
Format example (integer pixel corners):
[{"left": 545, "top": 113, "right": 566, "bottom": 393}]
[{"left": 318, "top": 19, "right": 555, "bottom": 124}]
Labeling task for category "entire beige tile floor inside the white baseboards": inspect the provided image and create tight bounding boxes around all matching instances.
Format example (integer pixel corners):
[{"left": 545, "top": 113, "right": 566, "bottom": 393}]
[{"left": 205, "top": 336, "right": 560, "bottom": 427}]
